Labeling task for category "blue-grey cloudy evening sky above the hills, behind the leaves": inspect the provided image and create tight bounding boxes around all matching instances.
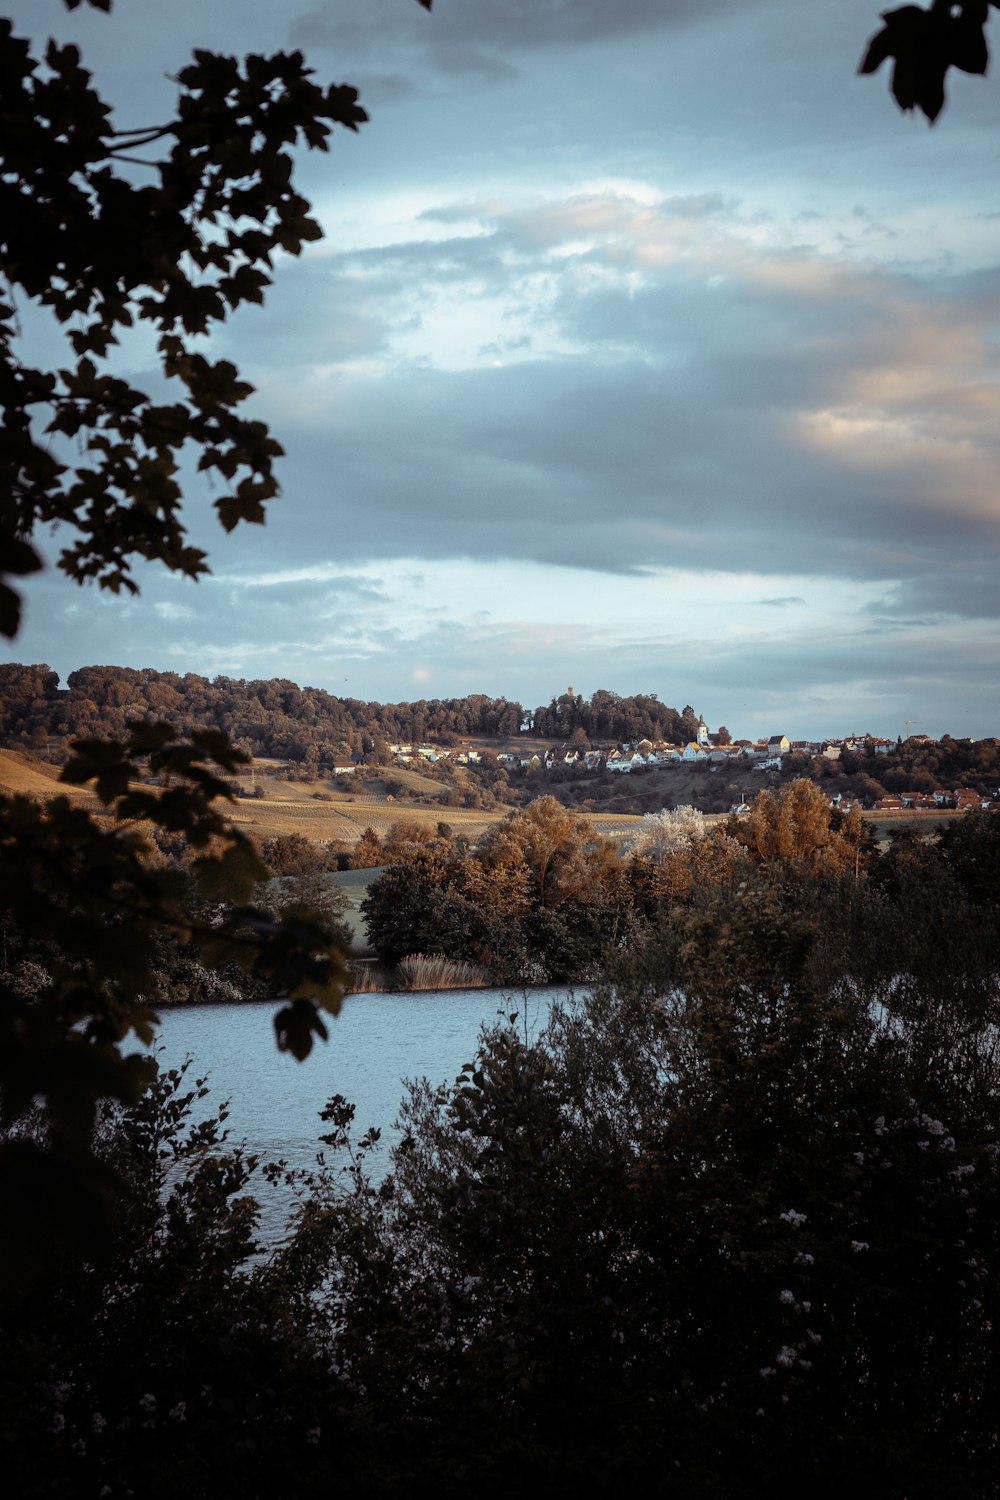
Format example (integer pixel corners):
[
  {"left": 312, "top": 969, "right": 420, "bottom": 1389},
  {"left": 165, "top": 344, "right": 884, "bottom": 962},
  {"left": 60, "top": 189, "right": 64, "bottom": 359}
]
[{"left": 9, "top": 0, "right": 1000, "bottom": 738}]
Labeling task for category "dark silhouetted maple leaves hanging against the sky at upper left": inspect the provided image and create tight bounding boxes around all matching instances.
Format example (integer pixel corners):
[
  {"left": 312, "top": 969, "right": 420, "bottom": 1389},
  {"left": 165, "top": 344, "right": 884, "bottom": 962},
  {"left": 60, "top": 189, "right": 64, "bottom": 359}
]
[{"left": 0, "top": 6, "right": 366, "bottom": 635}]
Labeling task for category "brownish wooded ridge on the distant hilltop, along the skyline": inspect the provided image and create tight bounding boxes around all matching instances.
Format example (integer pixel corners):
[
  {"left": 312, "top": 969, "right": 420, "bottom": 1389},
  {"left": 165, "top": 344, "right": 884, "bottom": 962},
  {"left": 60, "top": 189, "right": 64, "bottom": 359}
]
[{"left": 0, "top": 663, "right": 697, "bottom": 774}]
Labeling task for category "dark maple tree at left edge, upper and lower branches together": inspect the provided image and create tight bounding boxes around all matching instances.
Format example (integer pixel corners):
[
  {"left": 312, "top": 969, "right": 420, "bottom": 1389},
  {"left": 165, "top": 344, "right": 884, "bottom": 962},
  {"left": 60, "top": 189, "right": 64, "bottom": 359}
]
[{"left": 0, "top": 0, "right": 429, "bottom": 1298}]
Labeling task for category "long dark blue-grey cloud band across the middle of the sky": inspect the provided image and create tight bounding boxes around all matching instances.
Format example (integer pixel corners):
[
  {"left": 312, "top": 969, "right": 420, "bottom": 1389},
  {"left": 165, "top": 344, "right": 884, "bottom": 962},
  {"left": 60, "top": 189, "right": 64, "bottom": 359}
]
[{"left": 239, "top": 345, "right": 997, "bottom": 611}]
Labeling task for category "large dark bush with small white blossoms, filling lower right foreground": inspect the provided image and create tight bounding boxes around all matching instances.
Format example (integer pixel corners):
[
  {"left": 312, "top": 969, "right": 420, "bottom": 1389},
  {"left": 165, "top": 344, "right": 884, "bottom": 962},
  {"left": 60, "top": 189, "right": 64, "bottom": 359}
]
[{"left": 325, "top": 861, "right": 1000, "bottom": 1500}]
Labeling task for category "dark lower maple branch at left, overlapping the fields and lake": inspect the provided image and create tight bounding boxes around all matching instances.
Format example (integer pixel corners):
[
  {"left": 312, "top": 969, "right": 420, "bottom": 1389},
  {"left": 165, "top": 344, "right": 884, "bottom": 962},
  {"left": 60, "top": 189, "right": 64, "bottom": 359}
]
[{"left": 0, "top": 725, "right": 343, "bottom": 1298}]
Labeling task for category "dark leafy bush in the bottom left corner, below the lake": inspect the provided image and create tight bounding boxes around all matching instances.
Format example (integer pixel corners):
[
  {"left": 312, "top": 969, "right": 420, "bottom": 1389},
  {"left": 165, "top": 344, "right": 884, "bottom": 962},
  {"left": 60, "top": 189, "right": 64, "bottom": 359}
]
[{"left": 0, "top": 1065, "right": 374, "bottom": 1500}]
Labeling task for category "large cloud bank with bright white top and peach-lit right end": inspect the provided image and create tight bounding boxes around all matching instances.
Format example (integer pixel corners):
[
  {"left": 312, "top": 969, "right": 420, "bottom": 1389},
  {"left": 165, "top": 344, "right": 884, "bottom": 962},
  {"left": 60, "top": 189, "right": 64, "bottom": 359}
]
[{"left": 203, "top": 188, "right": 1000, "bottom": 614}]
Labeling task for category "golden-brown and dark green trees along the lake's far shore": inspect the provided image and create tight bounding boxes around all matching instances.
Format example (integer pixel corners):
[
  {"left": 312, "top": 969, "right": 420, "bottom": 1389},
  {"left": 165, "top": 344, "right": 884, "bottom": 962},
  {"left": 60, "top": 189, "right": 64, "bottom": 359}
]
[{"left": 355, "top": 780, "right": 1000, "bottom": 984}]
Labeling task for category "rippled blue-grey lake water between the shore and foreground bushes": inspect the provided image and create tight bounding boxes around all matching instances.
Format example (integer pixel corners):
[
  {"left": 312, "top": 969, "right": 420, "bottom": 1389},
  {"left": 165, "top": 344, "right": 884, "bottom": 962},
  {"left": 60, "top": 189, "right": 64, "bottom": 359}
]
[{"left": 150, "top": 987, "right": 567, "bottom": 1239}]
